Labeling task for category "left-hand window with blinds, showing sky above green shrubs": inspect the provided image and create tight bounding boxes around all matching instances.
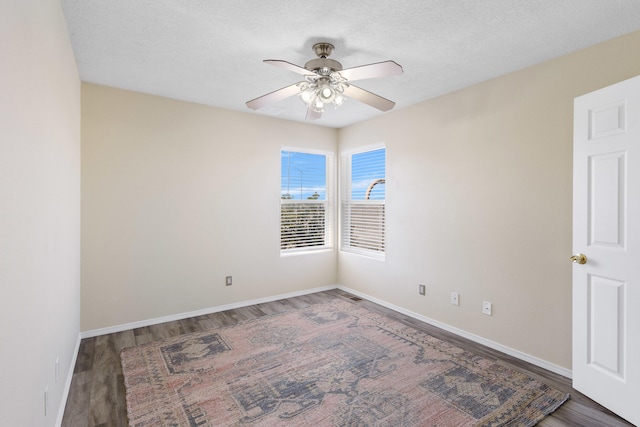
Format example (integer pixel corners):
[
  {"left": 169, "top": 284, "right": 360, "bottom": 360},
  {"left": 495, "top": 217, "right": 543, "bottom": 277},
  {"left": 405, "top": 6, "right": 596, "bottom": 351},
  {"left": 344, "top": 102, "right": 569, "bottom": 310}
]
[{"left": 280, "top": 149, "right": 333, "bottom": 254}]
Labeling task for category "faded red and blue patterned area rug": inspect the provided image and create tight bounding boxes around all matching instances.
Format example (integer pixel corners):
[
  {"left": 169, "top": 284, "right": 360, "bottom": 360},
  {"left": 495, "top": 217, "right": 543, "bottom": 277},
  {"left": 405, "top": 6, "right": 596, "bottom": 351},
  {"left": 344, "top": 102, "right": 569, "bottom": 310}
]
[{"left": 121, "top": 301, "right": 569, "bottom": 427}]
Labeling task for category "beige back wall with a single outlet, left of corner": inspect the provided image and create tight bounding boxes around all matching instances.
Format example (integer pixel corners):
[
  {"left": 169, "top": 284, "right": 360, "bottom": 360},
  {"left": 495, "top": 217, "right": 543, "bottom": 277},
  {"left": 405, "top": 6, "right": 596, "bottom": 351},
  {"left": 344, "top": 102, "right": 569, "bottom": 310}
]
[{"left": 82, "top": 84, "right": 337, "bottom": 331}]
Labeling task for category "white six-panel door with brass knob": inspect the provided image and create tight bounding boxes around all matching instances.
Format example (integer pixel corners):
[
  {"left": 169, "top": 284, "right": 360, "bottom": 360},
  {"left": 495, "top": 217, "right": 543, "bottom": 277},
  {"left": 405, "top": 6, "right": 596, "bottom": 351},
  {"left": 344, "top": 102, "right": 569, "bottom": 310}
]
[{"left": 572, "top": 76, "right": 640, "bottom": 426}]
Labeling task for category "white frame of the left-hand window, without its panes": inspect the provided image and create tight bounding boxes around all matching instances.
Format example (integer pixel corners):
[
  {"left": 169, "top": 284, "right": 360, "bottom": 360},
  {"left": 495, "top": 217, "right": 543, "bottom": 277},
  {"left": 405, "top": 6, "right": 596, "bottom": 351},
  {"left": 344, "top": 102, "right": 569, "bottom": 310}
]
[{"left": 279, "top": 146, "right": 336, "bottom": 256}]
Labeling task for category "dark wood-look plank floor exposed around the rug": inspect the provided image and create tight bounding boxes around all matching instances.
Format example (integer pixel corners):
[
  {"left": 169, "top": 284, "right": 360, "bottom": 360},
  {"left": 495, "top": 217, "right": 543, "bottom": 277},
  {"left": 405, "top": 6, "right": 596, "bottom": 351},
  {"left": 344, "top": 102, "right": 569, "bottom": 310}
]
[{"left": 62, "top": 290, "right": 632, "bottom": 427}]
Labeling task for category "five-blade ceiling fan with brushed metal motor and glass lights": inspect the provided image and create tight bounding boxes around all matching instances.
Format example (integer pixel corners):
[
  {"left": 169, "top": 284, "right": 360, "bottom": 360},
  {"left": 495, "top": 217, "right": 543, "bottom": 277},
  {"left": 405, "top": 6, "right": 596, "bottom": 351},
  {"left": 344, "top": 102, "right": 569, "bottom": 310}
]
[{"left": 247, "top": 42, "right": 402, "bottom": 120}]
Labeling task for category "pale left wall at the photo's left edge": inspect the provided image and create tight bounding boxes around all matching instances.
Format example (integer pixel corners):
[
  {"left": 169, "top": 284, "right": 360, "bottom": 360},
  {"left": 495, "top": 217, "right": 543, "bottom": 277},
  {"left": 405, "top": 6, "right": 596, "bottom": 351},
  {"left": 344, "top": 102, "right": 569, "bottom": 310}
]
[{"left": 0, "top": 0, "right": 80, "bottom": 426}]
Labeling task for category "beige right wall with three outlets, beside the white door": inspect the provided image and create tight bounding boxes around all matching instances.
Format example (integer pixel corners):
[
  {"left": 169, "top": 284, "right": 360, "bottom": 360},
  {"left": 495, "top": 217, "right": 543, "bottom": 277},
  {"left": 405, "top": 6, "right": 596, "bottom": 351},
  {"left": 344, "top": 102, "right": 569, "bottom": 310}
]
[{"left": 338, "top": 32, "right": 640, "bottom": 369}]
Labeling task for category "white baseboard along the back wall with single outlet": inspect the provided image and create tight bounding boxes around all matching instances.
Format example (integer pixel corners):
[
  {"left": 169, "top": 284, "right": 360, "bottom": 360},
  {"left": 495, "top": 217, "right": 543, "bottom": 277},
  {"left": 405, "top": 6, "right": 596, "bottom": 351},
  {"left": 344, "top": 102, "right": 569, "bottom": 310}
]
[{"left": 81, "top": 285, "right": 338, "bottom": 338}]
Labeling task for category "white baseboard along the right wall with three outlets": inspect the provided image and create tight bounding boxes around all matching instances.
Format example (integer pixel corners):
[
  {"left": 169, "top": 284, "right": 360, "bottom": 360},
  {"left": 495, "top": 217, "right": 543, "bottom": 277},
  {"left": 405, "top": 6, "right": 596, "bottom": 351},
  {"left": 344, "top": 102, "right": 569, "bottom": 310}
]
[{"left": 338, "top": 286, "right": 572, "bottom": 378}]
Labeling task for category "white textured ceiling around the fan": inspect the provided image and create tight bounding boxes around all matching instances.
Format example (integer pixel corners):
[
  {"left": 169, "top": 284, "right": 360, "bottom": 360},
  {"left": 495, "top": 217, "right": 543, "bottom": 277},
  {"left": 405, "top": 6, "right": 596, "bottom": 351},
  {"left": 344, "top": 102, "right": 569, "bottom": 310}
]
[{"left": 62, "top": 0, "right": 640, "bottom": 128}]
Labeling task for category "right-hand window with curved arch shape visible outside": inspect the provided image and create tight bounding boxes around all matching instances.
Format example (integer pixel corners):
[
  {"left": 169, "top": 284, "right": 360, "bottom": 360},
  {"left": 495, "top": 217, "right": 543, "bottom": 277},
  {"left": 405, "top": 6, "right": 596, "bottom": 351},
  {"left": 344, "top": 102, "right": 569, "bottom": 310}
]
[{"left": 341, "top": 148, "right": 386, "bottom": 258}]
